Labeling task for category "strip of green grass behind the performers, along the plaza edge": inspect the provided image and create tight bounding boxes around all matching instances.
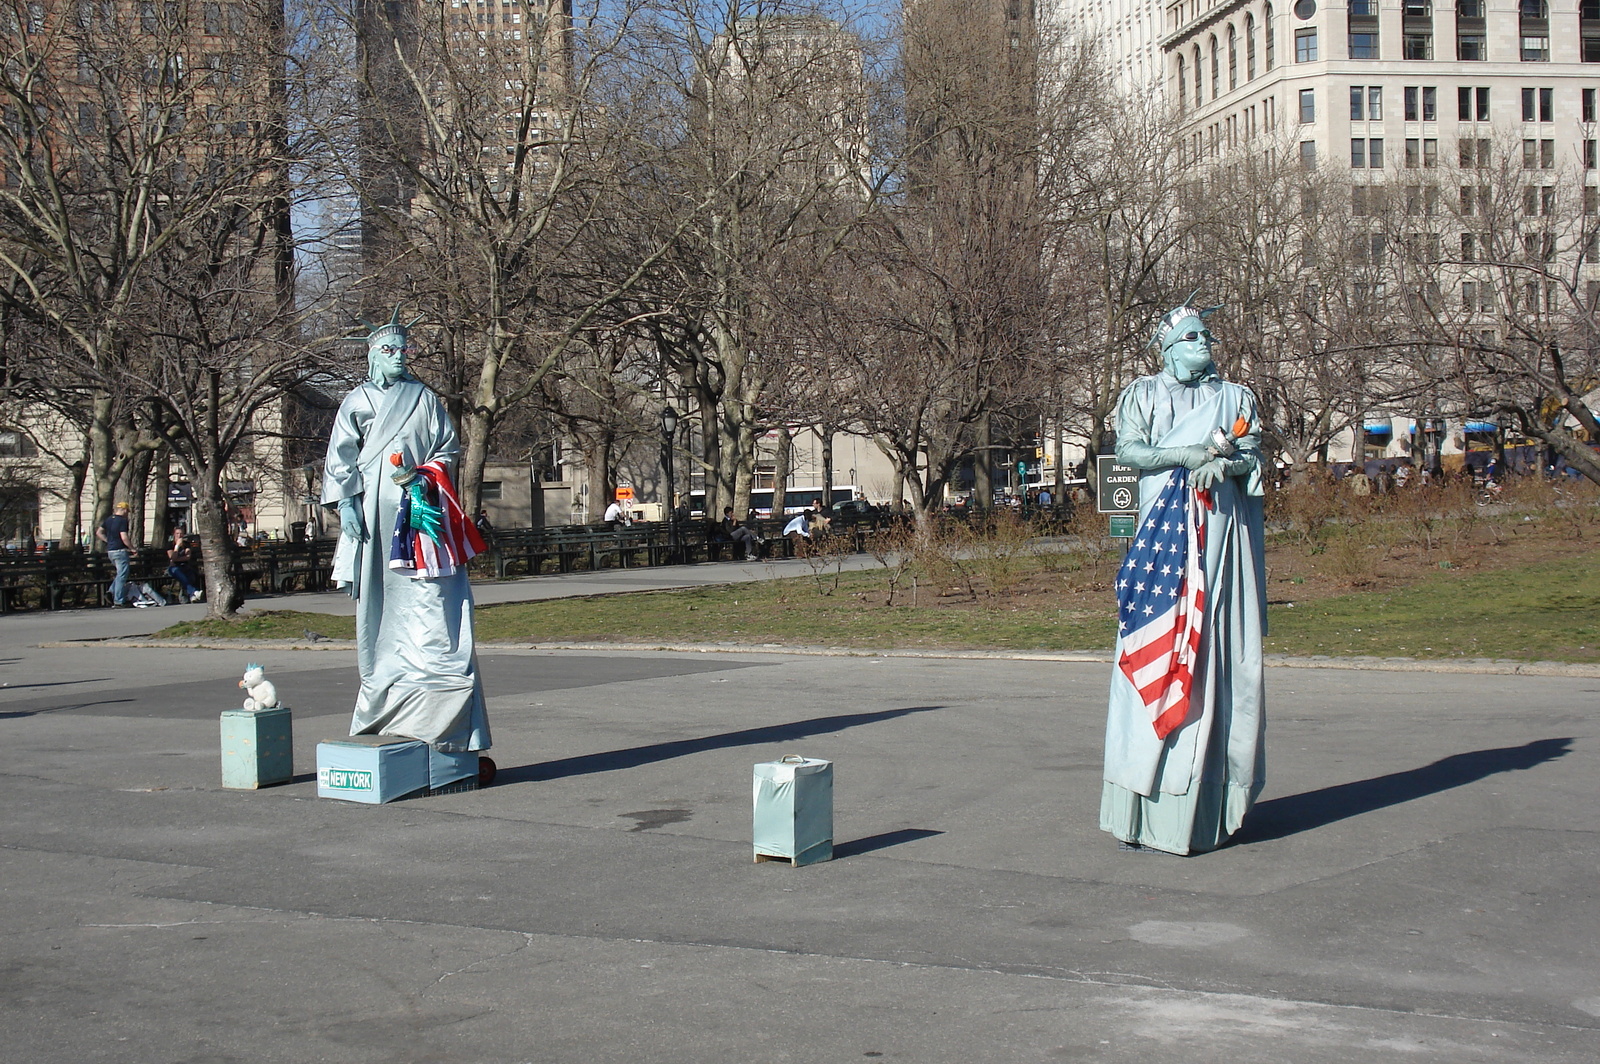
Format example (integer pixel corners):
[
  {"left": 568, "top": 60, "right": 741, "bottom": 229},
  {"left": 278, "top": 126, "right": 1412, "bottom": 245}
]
[{"left": 158, "top": 523, "right": 1600, "bottom": 662}]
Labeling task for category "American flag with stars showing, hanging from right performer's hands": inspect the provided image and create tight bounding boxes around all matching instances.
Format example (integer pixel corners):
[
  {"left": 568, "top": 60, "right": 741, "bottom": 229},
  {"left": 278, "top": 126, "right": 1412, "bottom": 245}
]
[{"left": 1117, "top": 469, "right": 1210, "bottom": 739}]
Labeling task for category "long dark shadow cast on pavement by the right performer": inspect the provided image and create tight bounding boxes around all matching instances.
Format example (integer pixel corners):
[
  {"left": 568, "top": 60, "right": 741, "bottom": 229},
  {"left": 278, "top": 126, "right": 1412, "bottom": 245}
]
[{"left": 1234, "top": 739, "right": 1573, "bottom": 843}]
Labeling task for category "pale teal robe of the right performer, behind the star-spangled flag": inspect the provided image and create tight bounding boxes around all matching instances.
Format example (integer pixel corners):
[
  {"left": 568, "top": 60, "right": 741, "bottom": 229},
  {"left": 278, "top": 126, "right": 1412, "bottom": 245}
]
[{"left": 1101, "top": 373, "right": 1267, "bottom": 854}]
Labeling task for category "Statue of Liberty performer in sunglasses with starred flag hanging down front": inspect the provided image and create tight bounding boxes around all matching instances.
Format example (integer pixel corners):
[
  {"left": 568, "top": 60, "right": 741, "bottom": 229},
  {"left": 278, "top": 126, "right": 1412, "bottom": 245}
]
[{"left": 1101, "top": 296, "right": 1267, "bottom": 854}]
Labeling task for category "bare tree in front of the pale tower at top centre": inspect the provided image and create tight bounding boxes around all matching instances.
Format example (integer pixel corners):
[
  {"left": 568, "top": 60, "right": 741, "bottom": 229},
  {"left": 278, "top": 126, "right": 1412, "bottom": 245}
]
[{"left": 608, "top": 0, "right": 874, "bottom": 512}]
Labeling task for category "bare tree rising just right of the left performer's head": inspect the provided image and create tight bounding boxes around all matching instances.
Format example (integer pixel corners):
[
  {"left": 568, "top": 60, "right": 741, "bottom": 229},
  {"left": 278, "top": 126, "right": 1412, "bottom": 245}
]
[{"left": 349, "top": 0, "right": 726, "bottom": 507}]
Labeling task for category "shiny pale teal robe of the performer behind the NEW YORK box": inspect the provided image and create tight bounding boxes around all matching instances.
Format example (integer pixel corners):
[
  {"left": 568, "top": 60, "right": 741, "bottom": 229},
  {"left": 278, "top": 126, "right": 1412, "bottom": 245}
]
[{"left": 322, "top": 378, "right": 490, "bottom": 752}]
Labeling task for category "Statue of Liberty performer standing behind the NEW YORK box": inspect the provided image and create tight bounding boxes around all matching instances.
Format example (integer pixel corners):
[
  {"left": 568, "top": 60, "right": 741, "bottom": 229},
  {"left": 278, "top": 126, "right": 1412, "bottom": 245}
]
[{"left": 322, "top": 310, "right": 491, "bottom": 755}]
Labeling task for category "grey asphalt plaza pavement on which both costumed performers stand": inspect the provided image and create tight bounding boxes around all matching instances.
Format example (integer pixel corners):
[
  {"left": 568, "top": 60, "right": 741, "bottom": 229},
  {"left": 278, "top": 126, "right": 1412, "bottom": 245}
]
[{"left": 0, "top": 566, "right": 1600, "bottom": 1064}]
